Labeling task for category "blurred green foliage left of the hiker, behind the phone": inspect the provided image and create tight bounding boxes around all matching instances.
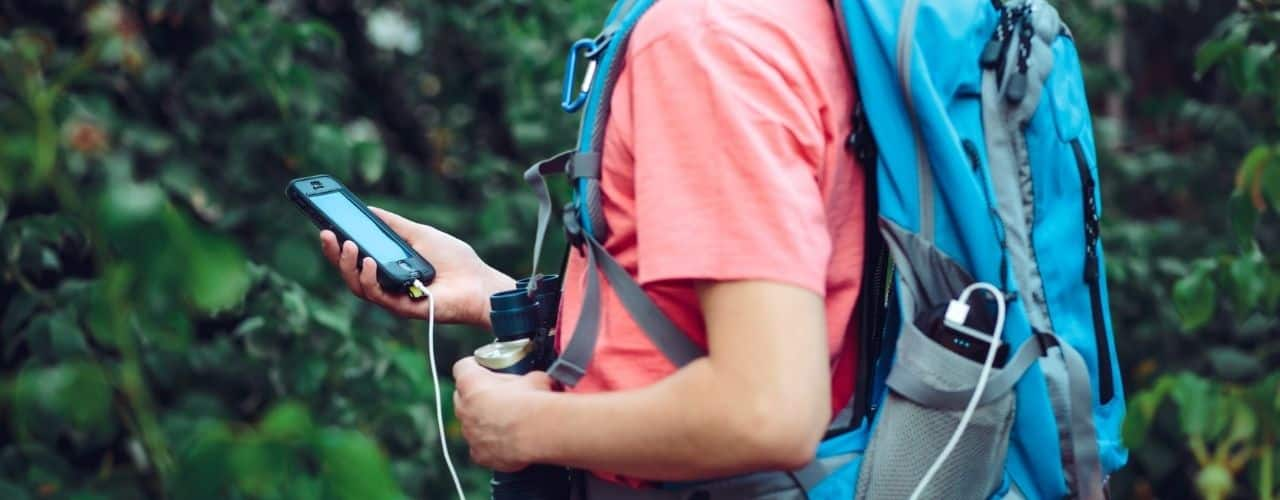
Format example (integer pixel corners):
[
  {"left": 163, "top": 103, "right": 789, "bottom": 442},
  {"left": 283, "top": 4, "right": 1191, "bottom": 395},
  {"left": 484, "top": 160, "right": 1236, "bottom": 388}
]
[{"left": 0, "top": 0, "right": 588, "bottom": 499}]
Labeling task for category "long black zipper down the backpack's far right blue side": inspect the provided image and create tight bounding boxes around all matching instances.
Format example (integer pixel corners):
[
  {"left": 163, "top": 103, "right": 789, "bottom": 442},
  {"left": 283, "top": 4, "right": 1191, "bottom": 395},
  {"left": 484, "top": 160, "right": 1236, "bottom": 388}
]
[{"left": 1071, "top": 139, "right": 1115, "bottom": 404}]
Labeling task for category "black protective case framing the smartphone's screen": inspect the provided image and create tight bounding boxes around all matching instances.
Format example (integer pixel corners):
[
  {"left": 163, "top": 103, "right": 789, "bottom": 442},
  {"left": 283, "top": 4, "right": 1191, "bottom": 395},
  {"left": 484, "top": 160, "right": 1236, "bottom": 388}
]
[{"left": 284, "top": 175, "right": 435, "bottom": 293}]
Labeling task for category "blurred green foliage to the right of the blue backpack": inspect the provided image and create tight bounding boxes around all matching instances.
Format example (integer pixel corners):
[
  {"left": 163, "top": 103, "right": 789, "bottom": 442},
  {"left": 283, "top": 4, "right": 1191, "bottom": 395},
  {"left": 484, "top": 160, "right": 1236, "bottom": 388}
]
[{"left": 1085, "top": 0, "right": 1280, "bottom": 499}]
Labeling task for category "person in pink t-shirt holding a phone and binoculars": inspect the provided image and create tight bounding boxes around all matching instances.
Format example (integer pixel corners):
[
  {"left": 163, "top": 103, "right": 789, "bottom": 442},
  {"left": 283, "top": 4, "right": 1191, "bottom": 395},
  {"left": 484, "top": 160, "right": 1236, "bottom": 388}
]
[{"left": 321, "top": 0, "right": 863, "bottom": 487}]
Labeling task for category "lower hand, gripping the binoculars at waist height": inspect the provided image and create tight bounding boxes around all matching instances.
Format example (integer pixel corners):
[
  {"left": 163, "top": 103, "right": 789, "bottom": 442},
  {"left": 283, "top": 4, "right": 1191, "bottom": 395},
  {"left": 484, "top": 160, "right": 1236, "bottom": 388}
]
[{"left": 453, "top": 358, "right": 552, "bottom": 472}]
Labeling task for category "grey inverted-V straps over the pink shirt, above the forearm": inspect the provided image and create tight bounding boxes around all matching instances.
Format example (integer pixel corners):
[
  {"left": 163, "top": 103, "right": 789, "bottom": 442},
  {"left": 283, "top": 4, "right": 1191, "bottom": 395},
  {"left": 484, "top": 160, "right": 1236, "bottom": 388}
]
[{"left": 548, "top": 235, "right": 705, "bottom": 386}]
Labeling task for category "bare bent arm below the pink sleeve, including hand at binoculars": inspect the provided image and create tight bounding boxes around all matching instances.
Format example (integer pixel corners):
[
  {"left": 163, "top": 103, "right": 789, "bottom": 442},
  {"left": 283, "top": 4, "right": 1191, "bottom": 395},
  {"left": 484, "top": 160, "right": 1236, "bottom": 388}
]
[{"left": 454, "top": 281, "right": 831, "bottom": 481}]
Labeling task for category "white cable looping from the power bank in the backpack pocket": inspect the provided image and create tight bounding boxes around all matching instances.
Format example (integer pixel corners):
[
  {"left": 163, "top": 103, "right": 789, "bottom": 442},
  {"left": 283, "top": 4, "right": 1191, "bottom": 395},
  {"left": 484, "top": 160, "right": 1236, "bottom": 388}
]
[{"left": 910, "top": 283, "right": 1005, "bottom": 500}]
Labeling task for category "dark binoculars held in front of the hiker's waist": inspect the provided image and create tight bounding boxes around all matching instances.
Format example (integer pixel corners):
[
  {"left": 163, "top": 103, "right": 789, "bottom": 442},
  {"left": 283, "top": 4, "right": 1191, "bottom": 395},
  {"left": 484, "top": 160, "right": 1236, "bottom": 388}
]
[{"left": 475, "top": 275, "right": 571, "bottom": 500}]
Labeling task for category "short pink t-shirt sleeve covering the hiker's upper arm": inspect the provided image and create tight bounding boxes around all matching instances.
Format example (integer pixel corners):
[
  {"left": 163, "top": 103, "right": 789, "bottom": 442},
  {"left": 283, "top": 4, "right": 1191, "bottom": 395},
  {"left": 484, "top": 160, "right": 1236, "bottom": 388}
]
[{"left": 626, "top": 19, "right": 832, "bottom": 294}]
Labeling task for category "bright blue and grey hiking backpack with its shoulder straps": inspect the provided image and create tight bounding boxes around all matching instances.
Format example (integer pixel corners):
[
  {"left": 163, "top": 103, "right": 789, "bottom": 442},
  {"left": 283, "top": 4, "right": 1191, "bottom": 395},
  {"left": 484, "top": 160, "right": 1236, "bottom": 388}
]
[{"left": 525, "top": 0, "right": 1128, "bottom": 499}]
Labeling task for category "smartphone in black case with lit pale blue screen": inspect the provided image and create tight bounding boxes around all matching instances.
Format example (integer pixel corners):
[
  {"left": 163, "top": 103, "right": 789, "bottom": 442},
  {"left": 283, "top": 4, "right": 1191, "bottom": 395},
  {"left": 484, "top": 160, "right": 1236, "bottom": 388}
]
[{"left": 284, "top": 175, "right": 435, "bottom": 298}]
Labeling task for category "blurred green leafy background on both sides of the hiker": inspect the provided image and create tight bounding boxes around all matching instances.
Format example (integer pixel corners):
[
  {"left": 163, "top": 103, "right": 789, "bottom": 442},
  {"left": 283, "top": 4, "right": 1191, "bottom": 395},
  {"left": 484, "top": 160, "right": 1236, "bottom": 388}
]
[{"left": 0, "top": 0, "right": 1280, "bottom": 499}]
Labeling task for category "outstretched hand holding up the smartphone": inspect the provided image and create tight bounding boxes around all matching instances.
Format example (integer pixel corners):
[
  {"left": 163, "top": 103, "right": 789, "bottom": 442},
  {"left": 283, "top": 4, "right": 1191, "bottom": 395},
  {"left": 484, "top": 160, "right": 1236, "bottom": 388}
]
[{"left": 320, "top": 207, "right": 516, "bottom": 325}]
